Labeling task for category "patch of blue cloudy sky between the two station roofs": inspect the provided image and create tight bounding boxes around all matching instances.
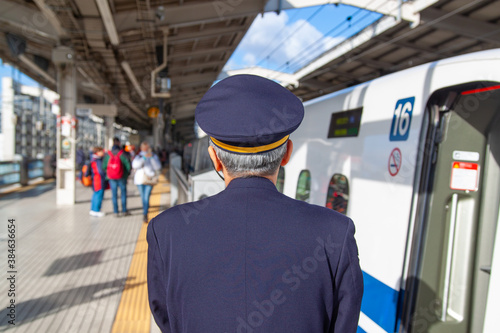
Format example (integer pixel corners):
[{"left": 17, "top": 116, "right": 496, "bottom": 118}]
[{"left": 224, "top": 4, "right": 381, "bottom": 73}]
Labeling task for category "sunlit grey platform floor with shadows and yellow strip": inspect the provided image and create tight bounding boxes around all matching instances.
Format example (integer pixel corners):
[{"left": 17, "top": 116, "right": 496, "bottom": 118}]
[{"left": 0, "top": 172, "right": 170, "bottom": 333}]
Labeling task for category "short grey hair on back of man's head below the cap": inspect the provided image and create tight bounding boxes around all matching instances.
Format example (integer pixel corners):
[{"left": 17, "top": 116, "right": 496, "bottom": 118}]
[{"left": 210, "top": 140, "right": 287, "bottom": 177}]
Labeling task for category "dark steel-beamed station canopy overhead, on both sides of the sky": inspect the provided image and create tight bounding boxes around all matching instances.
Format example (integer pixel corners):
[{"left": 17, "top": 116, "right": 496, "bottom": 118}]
[{"left": 0, "top": 0, "right": 500, "bottom": 140}]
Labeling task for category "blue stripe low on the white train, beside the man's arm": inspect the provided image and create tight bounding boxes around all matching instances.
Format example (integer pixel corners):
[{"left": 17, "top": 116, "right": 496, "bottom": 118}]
[{"left": 358, "top": 272, "right": 399, "bottom": 332}]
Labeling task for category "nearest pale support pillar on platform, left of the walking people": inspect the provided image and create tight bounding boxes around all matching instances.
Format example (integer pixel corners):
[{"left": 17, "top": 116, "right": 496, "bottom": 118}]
[{"left": 56, "top": 58, "right": 77, "bottom": 205}]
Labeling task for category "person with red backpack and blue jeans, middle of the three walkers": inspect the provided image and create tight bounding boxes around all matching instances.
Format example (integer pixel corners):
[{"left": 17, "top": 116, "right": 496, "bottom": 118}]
[{"left": 103, "top": 138, "right": 131, "bottom": 217}]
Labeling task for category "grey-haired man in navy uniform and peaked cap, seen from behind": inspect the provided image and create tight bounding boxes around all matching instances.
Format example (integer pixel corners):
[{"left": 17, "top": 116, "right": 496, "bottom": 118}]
[{"left": 147, "top": 75, "right": 363, "bottom": 333}]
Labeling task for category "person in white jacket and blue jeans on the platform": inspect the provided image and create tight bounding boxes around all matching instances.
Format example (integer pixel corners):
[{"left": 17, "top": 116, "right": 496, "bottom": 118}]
[{"left": 132, "top": 141, "right": 161, "bottom": 223}]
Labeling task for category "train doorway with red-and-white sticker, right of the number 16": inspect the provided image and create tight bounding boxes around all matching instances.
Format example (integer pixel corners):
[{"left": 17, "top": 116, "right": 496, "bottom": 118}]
[{"left": 403, "top": 82, "right": 500, "bottom": 333}]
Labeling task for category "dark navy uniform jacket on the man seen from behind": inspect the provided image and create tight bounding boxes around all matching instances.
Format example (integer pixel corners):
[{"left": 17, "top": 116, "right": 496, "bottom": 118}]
[{"left": 147, "top": 177, "right": 363, "bottom": 333}]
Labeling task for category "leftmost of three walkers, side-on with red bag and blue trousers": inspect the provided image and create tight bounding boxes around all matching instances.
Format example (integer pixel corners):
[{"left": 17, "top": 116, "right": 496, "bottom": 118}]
[{"left": 89, "top": 147, "right": 107, "bottom": 217}]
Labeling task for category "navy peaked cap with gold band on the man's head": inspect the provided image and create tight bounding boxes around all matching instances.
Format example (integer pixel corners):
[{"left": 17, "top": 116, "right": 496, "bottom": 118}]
[{"left": 195, "top": 74, "right": 304, "bottom": 154}]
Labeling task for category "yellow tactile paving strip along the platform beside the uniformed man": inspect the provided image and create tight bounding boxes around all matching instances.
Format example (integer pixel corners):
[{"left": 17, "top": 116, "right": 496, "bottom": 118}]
[{"left": 111, "top": 172, "right": 170, "bottom": 333}]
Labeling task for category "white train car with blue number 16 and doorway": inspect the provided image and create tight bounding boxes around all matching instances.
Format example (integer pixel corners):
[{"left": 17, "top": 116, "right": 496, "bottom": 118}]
[{"left": 279, "top": 49, "right": 500, "bottom": 333}]
